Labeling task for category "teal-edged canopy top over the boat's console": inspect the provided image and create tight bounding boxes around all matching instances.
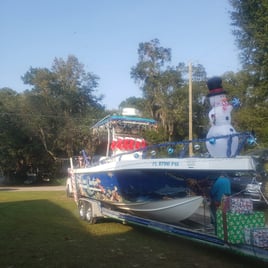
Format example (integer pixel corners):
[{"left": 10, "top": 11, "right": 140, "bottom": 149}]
[{"left": 92, "top": 115, "right": 156, "bottom": 128}]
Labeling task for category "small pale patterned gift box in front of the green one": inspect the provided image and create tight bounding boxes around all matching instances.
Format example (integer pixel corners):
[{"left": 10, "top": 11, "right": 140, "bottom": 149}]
[{"left": 245, "top": 227, "right": 268, "bottom": 248}]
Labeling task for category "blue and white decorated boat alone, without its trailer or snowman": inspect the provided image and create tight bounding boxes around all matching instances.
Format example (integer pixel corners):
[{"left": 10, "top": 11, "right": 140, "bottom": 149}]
[{"left": 66, "top": 108, "right": 264, "bottom": 223}]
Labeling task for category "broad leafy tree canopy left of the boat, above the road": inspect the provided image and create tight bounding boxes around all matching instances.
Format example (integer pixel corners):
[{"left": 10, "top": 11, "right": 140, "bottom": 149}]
[{"left": 0, "top": 56, "right": 105, "bottom": 182}]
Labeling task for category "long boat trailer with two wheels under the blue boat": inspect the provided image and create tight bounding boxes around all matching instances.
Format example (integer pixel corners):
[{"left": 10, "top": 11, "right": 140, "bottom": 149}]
[{"left": 78, "top": 198, "right": 268, "bottom": 262}]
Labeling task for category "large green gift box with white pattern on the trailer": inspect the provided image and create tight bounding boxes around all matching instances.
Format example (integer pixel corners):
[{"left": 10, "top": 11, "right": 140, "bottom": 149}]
[{"left": 216, "top": 210, "right": 265, "bottom": 244}]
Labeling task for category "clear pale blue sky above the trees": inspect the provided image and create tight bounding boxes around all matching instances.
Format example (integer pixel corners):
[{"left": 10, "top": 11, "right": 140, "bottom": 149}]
[{"left": 0, "top": 0, "right": 240, "bottom": 109}]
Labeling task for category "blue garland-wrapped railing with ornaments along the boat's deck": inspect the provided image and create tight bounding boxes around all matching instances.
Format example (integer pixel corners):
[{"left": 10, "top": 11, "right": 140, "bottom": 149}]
[{"left": 73, "top": 132, "right": 256, "bottom": 167}]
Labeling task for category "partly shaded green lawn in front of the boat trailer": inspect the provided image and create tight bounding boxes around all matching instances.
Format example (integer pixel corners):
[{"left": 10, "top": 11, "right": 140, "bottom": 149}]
[{"left": 0, "top": 191, "right": 267, "bottom": 268}]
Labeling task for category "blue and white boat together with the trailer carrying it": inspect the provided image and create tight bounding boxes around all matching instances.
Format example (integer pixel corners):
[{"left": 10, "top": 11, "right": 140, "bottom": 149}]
[{"left": 68, "top": 109, "right": 268, "bottom": 259}]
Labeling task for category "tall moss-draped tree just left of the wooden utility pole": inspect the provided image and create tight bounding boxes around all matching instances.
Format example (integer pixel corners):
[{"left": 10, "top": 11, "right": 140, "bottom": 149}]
[{"left": 131, "top": 39, "right": 189, "bottom": 140}]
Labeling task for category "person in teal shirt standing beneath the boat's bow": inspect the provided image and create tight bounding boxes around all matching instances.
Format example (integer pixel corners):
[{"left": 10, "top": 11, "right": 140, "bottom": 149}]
[{"left": 210, "top": 175, "right": 231, "bottom": 225}]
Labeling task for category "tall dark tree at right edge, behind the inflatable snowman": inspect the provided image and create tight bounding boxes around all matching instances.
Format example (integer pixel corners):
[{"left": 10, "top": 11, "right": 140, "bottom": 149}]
[{"left": 230, "top": 0, "right": 268, "bottom": 145}]
